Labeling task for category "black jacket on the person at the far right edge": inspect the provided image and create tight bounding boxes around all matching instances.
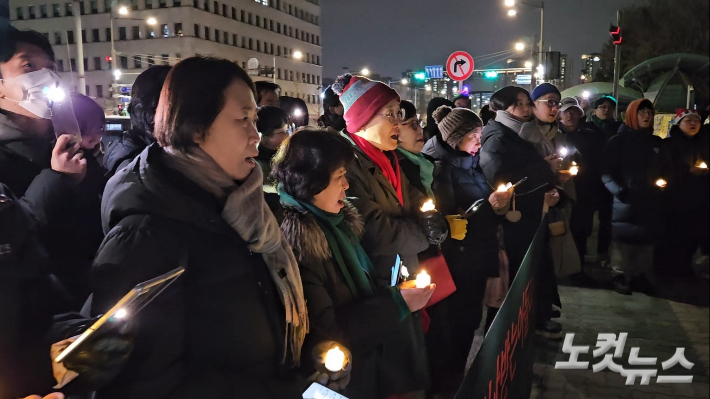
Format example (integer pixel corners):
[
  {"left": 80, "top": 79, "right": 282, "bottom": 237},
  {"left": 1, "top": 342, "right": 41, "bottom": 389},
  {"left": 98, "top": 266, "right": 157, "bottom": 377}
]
[{"left": 664, "top": 125, "right": 710, "bottom": 216}]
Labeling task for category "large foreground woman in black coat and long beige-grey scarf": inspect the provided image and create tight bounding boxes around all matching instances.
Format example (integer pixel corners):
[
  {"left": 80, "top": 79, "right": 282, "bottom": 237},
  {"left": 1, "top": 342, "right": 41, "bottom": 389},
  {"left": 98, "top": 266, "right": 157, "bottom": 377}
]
[{"left": 84, "top": 57, "right": 308, "bottom": 399}]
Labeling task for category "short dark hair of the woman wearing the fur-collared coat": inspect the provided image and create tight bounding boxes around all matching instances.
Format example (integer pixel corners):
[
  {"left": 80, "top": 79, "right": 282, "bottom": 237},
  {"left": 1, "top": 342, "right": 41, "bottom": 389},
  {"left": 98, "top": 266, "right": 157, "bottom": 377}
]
[{"left": 271, "top": 127, "right": 355, "bottom": 202}]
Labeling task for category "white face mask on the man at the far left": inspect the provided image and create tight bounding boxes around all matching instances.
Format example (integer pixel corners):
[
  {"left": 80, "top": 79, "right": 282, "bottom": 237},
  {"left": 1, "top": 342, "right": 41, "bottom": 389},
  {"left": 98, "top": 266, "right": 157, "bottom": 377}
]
[{"left": 0, "top": 68, "right": 60, "bottom": 119}]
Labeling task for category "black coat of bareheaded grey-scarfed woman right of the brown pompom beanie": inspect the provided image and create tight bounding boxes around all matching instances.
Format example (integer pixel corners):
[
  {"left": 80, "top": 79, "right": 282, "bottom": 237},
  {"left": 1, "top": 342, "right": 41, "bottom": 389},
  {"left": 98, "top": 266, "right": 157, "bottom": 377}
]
[{"left": 480, "top": 120, "right": 562, "bottom": 278}]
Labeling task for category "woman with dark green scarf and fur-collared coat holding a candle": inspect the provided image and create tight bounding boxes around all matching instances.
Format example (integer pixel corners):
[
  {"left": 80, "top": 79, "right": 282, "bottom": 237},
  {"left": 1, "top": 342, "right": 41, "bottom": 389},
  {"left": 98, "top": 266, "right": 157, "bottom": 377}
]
[{"left": 272, "top": 128, "right": 435, "bottom": 399}]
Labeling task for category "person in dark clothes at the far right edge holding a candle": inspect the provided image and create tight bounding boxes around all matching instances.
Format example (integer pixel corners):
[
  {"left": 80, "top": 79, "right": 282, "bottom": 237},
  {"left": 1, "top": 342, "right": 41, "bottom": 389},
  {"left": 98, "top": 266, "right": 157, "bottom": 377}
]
[{"left": 656, "top": 109, "right": 710, "bottom": 280}]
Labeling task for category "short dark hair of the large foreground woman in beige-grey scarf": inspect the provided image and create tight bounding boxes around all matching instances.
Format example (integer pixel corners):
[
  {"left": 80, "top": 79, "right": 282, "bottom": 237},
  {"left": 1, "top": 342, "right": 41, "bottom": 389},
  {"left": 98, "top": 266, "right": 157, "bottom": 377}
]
[{"left": 155, "top": 57, "right": 254, "bottom": 152}]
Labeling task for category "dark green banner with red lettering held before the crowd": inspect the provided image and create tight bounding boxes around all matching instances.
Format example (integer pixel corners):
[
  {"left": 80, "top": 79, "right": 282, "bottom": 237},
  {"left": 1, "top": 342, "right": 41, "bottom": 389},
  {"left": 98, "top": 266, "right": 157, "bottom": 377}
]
[{"left": 456, "top": 223, "right": 549, "bottom": 399}]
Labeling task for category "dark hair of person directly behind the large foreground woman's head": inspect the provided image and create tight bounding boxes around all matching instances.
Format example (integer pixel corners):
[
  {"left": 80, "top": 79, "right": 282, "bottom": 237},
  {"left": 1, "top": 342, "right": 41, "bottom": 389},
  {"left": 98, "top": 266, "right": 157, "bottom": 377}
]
[{"left": 128, "top": 65, "right": 171, "bottom": 137}]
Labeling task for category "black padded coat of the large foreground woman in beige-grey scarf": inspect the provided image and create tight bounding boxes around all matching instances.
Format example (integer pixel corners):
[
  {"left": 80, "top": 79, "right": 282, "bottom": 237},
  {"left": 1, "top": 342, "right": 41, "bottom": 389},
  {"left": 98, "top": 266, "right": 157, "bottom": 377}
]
[{"left": 91, "top": 144, "right": 304, "bottom": 399}]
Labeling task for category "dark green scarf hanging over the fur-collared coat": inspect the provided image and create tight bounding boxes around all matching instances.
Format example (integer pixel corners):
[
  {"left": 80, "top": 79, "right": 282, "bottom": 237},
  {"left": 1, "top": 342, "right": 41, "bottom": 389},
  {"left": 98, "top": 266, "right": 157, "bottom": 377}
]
[{"left": 278, "top": 187, "right": 376, "bottom": 298}]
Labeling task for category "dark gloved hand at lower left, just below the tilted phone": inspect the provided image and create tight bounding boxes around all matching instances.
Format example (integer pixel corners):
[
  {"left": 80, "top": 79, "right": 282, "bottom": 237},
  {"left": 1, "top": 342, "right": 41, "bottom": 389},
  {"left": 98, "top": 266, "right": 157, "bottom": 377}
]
[{"left": 57, "top": 316, "right": 133, "bottom": 389}]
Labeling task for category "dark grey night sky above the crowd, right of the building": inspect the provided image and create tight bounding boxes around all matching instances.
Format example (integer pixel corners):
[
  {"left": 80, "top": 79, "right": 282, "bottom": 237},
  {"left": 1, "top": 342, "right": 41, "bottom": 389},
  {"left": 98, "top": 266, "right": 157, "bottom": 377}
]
[{"left": 321, "top": 0, "right": 647, "bottom": 82}]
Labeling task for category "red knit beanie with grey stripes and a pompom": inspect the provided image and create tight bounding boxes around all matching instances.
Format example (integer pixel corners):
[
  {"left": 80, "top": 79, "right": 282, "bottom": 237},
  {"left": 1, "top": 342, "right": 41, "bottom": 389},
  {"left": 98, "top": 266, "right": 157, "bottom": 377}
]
[{"left": 331, "top": 74, "right": 400, "bottom": 133}]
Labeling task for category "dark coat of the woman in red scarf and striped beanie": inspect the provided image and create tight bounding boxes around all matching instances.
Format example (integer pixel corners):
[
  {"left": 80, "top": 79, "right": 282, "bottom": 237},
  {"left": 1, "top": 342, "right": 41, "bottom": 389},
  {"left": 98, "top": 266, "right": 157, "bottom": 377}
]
[{"left": 341, "top": 134, "right": 429, "bottom": 285}]
